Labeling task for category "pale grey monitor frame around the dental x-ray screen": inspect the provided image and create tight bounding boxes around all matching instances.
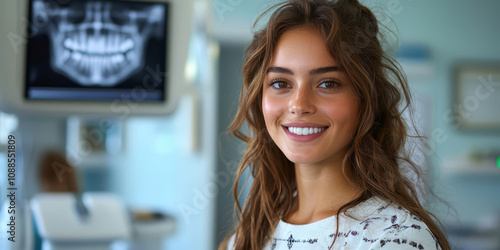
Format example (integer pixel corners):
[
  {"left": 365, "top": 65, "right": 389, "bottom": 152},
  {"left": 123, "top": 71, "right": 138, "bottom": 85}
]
[{"left": 0, "top": 0, "right": 193, "bottom": 118}]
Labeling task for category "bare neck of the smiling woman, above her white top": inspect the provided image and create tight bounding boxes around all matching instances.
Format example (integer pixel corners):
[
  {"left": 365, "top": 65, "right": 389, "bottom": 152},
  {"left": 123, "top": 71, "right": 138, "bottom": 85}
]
[{"left": 284, "top": 156, "right": 361, "bottom": 224}]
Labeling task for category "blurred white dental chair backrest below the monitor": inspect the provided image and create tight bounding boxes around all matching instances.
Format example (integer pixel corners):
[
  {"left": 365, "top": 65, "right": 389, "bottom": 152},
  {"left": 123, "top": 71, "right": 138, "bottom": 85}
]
[{"left": 30, "top": 193, "right": 132, "bottom": 250}]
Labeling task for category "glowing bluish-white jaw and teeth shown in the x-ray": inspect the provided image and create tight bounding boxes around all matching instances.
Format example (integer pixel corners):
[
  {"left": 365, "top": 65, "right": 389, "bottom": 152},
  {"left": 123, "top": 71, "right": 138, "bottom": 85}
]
[{"left": 33, "top": 0, "right": 165, "bottom": 86}]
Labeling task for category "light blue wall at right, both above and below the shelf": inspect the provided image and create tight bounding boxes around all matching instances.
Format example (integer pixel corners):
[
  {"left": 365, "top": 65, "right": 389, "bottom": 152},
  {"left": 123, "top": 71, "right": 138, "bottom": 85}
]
[{"left": 376, "top": 0, "right": 500, "bottom": 224}]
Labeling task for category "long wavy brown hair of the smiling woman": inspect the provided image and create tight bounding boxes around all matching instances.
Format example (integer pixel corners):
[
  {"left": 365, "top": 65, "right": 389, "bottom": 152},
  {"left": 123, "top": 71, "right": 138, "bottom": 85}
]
[{"left": 219, "top": 0, "right": 450, "bottom": 250}]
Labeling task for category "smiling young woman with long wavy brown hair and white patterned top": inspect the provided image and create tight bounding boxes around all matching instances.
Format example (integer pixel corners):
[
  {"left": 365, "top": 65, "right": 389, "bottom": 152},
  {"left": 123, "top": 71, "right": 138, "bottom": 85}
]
[{"left": 219, "top": 0, "right": 450, "bottom": 250}]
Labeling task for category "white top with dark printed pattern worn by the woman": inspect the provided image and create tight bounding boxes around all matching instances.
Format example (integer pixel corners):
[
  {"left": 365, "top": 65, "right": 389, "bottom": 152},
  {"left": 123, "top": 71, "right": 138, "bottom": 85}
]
[{"left": 228, "top": 197, "right": 441, "bottom": 250}]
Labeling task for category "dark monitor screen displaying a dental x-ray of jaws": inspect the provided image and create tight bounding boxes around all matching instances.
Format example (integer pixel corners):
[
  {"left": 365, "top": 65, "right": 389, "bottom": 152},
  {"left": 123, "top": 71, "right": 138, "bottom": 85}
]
[{"left": 26, "top": 0, "right": 168, "bottom": 101}]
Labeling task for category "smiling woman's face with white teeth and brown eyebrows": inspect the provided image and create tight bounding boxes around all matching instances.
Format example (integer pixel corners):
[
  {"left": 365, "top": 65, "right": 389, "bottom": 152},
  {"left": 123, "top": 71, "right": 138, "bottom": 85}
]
[{"left": 262, "top": 28, "right": 358, "bottom": 164}]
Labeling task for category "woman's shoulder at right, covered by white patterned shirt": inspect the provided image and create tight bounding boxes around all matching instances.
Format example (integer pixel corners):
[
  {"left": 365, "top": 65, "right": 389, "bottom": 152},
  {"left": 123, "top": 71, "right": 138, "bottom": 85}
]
[{"left": 338, "top": 197, "right": 440, "bottom": 249}]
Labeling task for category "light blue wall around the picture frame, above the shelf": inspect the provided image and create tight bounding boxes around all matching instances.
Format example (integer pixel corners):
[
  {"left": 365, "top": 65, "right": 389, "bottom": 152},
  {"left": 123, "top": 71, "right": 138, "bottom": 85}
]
[{"left": 382, "top": 0, "right": 500, "bottom": 159}]
